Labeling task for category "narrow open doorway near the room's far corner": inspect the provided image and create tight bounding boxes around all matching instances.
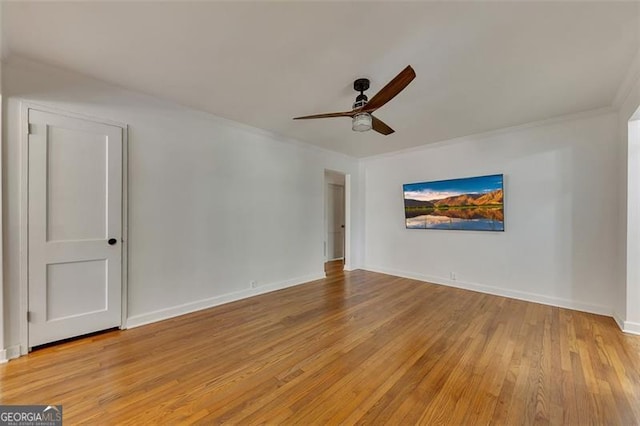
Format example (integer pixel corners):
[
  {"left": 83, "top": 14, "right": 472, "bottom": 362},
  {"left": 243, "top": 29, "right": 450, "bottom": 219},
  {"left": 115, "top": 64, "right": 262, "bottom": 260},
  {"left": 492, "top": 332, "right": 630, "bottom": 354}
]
[{"left": 324, "top": 170, "right": 346, "bottom": 276}]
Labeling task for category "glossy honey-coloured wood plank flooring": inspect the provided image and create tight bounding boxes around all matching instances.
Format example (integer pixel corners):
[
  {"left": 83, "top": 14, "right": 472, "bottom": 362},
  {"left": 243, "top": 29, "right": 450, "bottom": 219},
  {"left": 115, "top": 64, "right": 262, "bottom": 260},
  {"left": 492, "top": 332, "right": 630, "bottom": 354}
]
[{"left": 0, "top": 264, "right": 640, "bottom": 425}]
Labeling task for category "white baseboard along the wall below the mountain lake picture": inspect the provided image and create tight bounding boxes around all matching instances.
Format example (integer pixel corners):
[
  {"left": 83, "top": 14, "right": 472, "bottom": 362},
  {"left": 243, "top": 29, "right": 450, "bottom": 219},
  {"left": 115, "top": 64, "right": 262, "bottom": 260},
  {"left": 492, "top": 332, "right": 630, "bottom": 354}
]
[{"left": 364, "top": 265, "right": 612, "bottom": 317}]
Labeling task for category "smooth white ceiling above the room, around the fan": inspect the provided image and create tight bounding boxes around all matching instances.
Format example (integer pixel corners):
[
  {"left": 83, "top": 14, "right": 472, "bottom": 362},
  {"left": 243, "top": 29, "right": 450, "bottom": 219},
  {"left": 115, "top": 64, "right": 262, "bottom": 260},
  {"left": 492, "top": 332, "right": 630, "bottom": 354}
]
[{"left": 3, "top": 1, "right": 640, "bottom": 157}]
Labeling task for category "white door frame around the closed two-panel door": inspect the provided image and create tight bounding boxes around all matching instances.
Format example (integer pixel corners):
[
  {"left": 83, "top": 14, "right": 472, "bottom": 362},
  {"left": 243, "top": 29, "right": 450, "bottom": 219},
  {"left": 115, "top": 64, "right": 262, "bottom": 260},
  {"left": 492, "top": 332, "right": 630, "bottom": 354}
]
[{"left": 19, "top": 100, "right": 129, "bottom": 355}]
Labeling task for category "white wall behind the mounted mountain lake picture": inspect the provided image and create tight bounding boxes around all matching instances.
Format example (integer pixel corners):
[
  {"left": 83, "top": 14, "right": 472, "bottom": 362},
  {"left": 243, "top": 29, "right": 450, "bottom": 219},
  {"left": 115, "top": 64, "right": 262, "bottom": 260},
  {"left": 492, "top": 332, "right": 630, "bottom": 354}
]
[{"left": 364, "top": 112, "right": 621, "bottom": 315}]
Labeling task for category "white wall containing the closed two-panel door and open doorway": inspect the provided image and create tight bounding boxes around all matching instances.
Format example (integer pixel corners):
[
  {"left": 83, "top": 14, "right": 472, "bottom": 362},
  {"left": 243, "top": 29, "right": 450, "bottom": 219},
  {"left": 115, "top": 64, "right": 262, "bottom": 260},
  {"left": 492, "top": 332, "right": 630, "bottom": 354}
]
[{"left": 3, "top": 57, "right": 362, "bottom": 354}]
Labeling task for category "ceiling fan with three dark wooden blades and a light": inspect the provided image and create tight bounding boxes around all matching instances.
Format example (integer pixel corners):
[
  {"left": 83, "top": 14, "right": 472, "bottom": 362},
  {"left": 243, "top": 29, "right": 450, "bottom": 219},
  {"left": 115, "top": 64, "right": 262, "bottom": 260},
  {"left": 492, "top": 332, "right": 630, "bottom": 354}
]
[{"left": 294, "top": 65, "right": 416, "bottom": 135}]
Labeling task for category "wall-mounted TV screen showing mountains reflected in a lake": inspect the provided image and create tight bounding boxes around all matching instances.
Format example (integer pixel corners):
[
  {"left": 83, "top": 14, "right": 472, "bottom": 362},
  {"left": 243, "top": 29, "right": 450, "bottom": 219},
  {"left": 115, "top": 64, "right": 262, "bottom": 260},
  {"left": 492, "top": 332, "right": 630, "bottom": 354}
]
[{"left": 403, "top": 175, "right": 504, "bottom": 231}]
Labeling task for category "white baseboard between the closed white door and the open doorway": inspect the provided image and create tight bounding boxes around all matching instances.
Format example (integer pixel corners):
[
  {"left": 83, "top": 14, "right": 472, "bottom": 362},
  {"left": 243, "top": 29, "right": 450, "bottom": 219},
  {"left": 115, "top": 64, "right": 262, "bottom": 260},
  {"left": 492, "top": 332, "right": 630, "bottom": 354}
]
[{"left": 124, "top": 272, "right": 325, "bottom": 328}]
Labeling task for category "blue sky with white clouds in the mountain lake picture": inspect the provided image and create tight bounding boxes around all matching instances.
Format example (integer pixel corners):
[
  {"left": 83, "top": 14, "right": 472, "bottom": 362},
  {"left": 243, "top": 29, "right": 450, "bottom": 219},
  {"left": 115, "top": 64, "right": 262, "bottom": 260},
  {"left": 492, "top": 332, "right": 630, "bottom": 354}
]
[{"left": 403, "top": 175, "right": 502, "bottom": 201}]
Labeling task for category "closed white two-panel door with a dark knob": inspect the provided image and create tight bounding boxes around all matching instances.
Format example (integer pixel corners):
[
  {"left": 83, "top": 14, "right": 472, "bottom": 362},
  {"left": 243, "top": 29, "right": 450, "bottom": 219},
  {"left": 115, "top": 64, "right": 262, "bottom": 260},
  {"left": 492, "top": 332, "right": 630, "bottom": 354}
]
[{"left": 28, "top": 109, "right": 123, "bottom": 347}]
